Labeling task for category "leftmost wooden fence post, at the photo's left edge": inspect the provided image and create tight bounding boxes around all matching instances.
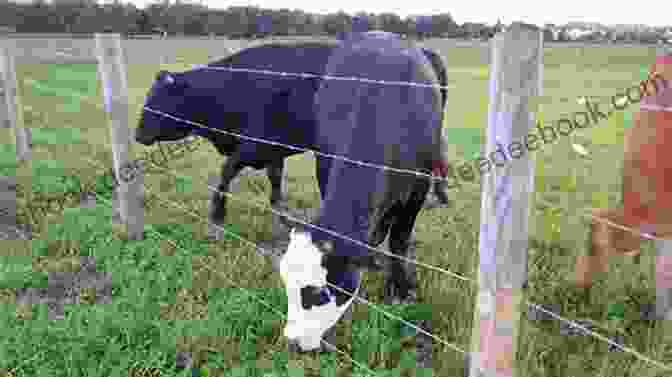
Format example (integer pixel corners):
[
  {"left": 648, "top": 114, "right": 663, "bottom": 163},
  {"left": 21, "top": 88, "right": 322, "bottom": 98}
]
[{"left": 0, "top": 39, "right": 31, "bottom": 162}]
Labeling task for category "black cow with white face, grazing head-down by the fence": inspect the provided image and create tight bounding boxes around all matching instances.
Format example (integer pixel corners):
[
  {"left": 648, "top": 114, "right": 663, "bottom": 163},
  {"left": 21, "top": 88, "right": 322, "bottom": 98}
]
[{"left": 281, "top": 33, "right": 442, "bottom": 350}]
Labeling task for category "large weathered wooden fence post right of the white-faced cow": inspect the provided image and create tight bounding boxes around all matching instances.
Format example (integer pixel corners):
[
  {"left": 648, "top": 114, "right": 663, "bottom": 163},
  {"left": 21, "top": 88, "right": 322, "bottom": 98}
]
[{"left": 469, "top": 22, "right": 543, "bottom": 377}]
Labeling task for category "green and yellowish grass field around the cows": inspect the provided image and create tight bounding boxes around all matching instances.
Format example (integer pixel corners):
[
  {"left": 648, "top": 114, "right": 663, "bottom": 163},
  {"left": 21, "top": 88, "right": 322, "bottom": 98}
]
[{"left": 0, "top": 41, "right": 672, "bottom": 377}]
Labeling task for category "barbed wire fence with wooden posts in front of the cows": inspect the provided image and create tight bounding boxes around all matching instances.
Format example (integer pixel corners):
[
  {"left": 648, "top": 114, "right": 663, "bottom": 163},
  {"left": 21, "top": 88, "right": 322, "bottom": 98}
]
[{"left": 0, "top": 24, "right": 672, "bottom": 377}]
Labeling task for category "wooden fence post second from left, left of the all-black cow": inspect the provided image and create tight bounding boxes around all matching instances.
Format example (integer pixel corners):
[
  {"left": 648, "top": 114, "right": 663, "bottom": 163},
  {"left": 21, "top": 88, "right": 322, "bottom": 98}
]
[{"left": 95, "top": 34, "right": 144, "bottom": 240}]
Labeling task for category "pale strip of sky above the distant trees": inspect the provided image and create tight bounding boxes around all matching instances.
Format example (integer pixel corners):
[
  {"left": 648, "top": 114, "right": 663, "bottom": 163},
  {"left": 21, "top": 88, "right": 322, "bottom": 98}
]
[{"left": 118, "top": 0, "right": 672, "bottom": 26}]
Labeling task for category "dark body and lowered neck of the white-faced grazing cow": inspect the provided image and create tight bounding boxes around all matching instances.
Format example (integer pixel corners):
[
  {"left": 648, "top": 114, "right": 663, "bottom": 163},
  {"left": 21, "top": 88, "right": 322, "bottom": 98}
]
[{"left": 313, "top": 34, "right": 441, "bottom": 255}]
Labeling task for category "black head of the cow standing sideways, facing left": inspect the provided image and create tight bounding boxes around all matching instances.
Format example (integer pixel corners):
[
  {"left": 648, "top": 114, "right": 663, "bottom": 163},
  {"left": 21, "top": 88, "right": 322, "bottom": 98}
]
[{"left": 135, "top": 71, "right": 198, "bottom": 145}]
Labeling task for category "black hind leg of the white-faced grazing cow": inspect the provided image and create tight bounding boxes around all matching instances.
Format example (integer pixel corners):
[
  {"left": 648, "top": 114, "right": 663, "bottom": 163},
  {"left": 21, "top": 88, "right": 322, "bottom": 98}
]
[{"left": 385, "top": 180, "right": 429, "bottom": 304}]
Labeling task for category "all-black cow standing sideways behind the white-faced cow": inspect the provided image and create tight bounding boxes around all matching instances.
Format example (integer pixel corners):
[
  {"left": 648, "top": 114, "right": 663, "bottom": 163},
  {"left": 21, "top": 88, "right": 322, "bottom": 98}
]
[{"left": 136, "top": 41, "right": 447, "bottom": 236}]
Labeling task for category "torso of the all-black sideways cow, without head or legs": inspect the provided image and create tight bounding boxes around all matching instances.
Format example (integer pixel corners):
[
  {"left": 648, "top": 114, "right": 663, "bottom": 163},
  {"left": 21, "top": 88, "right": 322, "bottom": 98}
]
[{"left": 185, "top": 42, "right": 336, "bottom": 161}]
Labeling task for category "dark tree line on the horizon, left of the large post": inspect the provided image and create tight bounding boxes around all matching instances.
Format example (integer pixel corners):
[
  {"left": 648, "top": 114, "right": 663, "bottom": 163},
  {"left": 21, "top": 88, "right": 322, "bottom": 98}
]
[{"left": 0, "top": 0, "right": 497, "bottom": 38}]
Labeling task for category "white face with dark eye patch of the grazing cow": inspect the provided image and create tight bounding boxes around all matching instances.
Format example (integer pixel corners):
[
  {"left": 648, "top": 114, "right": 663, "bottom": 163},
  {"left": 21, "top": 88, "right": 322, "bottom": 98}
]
[{"left": 280, "top": 229, "right": 357, "bottom": 351}]
